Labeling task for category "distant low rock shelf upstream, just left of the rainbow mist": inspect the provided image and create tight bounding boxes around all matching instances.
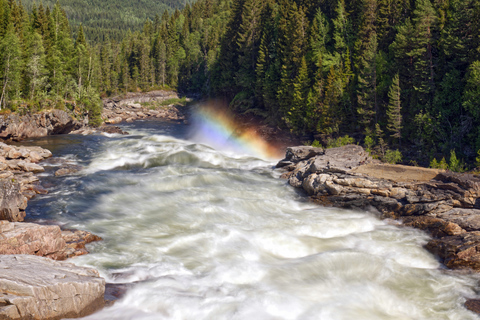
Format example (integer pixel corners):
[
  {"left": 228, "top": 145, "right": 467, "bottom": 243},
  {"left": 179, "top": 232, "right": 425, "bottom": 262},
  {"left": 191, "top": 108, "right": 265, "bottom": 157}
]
[{"left": 102, "top": 90, "right": 185, "bottom": 124}]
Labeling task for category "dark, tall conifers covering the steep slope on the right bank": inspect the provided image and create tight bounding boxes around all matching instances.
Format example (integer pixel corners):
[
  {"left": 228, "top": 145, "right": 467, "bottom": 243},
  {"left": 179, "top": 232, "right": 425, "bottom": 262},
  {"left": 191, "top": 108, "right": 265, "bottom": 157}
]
[{"left": 214, "top": 0, "right": 480, "bottom": 166}]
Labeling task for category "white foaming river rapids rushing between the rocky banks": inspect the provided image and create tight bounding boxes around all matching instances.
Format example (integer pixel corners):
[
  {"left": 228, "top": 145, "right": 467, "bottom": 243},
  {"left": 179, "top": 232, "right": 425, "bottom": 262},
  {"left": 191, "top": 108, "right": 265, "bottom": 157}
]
[{"left": 28, "top": 122, "right": 478, "bottom": 320}]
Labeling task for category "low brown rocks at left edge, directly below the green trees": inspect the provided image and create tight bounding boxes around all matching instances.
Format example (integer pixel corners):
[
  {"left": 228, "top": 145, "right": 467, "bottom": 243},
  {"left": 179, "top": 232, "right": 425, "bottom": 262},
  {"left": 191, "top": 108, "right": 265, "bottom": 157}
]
[{"left": 0, "top": 109, "right": 84, "bottom": 140}]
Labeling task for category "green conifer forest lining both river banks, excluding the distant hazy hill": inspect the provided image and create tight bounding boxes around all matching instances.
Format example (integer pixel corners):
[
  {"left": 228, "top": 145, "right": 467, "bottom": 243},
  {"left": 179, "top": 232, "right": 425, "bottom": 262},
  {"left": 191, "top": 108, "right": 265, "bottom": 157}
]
[{"left": 0, "top": 0, "right": 480, "bottom": 168}]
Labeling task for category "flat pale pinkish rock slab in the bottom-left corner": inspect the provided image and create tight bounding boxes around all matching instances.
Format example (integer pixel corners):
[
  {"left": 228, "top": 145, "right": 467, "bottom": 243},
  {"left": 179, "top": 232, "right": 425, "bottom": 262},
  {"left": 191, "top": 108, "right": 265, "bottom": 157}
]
[{"left": 0, "top": 255, "right": 105, "bottom": 320}]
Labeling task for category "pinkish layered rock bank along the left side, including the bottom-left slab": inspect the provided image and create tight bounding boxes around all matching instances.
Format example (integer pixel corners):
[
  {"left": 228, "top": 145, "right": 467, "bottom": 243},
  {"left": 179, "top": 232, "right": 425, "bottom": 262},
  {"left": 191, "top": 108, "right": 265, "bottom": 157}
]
[{"left": 0, "top": 143, "right": 105, "bottom": 319}]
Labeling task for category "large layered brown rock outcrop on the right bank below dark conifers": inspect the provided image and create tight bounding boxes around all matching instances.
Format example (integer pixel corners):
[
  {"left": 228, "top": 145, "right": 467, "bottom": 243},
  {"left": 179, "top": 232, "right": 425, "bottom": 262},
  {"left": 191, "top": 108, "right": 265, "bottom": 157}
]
[{"left": 277, "top": 145, "right": 480, "bottom": 272}]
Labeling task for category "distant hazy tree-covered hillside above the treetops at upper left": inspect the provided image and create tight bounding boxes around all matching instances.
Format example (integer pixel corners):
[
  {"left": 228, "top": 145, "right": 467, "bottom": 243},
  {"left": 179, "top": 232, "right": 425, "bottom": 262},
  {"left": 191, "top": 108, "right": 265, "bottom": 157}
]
[{"left": 22, "top": 0, "right": 191, "bottom": 42}]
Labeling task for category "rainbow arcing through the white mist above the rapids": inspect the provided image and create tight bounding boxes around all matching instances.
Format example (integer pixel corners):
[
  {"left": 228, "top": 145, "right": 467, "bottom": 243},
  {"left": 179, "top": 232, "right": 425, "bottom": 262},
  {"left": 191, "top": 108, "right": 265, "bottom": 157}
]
[{"left": 191, "top": 103, "right": 283, "bottom": 160}]
